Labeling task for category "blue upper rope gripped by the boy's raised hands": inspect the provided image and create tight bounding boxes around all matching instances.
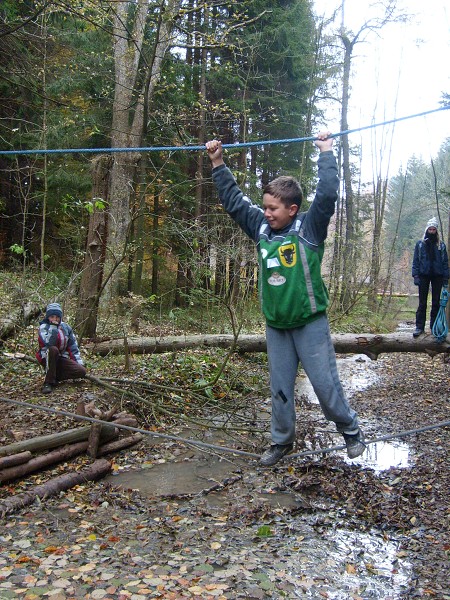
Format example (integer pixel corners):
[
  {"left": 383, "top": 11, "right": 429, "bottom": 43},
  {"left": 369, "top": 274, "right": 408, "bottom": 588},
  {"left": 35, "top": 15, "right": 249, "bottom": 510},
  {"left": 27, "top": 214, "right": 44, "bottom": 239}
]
[{"left": 0, "top": 104, "right": 450, "bottom": 156}]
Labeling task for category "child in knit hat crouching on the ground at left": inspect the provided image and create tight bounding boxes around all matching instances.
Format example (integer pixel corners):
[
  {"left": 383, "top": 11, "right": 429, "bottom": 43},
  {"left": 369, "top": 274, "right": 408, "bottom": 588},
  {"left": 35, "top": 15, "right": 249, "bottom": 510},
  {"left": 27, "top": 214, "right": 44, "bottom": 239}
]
[{"left": 36, "top": 302, "right": 86, "bottom": 394}]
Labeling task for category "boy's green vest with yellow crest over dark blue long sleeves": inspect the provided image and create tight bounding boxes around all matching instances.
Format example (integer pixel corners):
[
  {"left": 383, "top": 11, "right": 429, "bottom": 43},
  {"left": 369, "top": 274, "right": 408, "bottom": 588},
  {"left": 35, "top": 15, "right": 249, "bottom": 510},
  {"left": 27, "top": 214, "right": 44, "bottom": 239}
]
[{"left": 213, "top": 151, "right": 339, "bottom": 329}]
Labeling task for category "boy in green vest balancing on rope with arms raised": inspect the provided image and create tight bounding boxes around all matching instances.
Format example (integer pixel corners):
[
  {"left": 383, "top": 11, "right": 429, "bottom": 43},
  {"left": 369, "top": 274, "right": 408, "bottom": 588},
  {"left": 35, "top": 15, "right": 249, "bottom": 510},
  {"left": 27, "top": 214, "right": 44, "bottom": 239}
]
[{"left": 206, "top": 132, "right": 366, "bottom": 466}]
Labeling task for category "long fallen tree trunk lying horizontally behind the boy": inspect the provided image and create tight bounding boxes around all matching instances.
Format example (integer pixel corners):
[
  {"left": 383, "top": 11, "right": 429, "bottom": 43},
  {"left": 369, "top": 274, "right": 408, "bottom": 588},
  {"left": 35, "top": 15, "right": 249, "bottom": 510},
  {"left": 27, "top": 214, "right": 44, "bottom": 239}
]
[{"left": 86, "top": 333, "right": 450, "bottom": 359}]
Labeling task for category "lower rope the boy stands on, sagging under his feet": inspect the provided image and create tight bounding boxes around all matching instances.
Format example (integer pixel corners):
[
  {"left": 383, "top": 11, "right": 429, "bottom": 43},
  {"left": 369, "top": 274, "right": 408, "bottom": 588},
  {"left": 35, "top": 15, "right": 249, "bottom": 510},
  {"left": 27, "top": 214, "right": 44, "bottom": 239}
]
[{"left": 0, "top": 397, "right": 450, "bottom": 459}]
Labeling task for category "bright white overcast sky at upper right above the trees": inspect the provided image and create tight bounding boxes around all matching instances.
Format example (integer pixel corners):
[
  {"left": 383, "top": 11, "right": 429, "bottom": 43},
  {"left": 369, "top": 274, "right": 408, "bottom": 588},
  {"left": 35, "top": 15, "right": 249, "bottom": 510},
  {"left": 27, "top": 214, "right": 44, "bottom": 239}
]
[{"left": 314, "top": 0, "right": 450, "bottom": 177}]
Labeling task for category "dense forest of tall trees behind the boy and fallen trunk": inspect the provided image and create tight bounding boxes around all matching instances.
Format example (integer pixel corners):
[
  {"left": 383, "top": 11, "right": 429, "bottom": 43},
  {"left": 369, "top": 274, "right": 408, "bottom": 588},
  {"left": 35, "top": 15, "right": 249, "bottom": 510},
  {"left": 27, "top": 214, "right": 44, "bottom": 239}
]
[{"left": 0, "top": 0, "right": 450, "bottom": 337}]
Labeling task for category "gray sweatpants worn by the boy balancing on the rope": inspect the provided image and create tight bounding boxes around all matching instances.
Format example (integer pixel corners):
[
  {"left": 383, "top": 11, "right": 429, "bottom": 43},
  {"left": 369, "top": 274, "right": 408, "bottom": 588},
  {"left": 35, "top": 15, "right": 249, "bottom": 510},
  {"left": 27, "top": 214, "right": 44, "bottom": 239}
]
[{"left": 266, "top": 314, "right": 358, "bottom": 444}]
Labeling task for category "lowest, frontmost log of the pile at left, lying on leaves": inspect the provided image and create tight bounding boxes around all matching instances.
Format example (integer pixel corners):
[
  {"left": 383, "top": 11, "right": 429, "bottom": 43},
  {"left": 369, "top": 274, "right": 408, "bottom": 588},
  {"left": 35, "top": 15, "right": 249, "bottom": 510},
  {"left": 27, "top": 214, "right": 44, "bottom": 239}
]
[{"left": 0, "top": 458, "right": 111, "bottom": 516}]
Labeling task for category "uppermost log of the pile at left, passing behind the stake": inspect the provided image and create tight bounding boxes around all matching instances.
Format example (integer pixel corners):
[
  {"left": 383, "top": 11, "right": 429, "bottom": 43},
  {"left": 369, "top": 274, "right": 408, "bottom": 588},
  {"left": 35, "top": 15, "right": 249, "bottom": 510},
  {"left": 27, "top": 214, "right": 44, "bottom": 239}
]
[{"left": 0, "top": 425, "right": 118, "bottom": 456}]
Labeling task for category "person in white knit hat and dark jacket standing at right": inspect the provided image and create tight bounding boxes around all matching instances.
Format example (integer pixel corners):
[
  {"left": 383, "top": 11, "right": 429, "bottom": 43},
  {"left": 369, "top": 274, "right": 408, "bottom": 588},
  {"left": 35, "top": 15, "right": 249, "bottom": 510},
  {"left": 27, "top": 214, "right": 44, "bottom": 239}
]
[{"left": 412, "top": 217, "right": 449, "bottom": 338}]
